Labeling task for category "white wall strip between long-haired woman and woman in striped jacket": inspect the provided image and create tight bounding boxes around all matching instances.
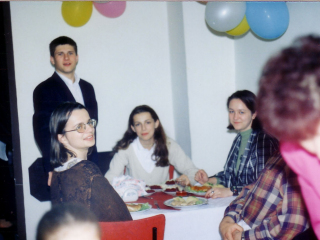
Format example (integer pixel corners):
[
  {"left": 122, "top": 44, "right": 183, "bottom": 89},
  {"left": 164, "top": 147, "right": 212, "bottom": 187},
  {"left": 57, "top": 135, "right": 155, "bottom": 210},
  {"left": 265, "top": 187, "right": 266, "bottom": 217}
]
[{"left": 183, "top": 2, "right": 235, "bottom": 175}]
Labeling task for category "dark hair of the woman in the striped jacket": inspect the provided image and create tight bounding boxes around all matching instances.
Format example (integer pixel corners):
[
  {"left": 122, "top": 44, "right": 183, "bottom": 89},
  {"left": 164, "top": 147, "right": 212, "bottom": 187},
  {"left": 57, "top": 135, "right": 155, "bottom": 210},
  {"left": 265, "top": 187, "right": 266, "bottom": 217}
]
[{"left": 227, "top": 90, "right": 262, "bottom": 130}]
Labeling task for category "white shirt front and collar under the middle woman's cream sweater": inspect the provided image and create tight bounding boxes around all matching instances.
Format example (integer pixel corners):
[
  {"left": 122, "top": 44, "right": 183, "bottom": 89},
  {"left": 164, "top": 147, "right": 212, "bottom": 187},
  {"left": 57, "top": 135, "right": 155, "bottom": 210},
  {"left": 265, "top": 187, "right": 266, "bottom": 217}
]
[{"left": 132, "top": 137, "right": 156, "bottom": 173}]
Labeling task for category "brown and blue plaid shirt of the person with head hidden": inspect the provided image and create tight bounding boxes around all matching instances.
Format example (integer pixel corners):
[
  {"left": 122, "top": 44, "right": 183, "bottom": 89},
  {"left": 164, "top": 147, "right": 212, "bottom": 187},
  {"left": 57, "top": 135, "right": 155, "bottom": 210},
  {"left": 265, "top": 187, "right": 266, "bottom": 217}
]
[{"left": 225, "top": 153, "right": 308, "bottom": 240}]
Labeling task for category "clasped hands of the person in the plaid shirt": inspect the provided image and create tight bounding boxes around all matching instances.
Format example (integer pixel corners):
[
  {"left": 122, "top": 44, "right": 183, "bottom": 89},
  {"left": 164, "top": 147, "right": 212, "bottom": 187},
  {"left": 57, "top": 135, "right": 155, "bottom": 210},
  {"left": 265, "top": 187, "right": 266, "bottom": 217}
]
[{"left": 219, "top": 216, "right": 243, "bottom": 240}]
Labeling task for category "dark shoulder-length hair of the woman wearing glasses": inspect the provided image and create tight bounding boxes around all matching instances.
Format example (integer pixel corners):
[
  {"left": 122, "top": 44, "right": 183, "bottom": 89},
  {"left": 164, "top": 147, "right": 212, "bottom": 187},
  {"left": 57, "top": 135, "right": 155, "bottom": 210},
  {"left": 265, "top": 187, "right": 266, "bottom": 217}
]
[{"left": 49, "top": 102, "right": 92, "bottom": 168}]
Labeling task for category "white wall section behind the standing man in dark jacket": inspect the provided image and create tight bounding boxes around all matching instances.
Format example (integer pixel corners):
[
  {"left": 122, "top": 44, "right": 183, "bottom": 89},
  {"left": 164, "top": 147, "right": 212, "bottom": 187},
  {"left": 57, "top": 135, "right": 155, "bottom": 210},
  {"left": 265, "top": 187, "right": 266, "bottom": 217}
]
[{"left": 10, "top": 1, "right": 175, "bottom": 240}]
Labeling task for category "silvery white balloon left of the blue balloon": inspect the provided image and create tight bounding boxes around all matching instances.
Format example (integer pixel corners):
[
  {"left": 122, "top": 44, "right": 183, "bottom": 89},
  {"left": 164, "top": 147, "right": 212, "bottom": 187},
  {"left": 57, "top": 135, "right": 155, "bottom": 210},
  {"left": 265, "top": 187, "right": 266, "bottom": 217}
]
[{"left": 205, "top": 2, "right": 246, "bottom": 32}]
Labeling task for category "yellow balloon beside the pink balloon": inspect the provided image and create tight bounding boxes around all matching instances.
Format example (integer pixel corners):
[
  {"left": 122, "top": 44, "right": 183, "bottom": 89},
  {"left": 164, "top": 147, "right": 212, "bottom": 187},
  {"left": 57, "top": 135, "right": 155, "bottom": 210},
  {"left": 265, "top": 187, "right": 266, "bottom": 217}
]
[{"left": 61, "top": 1, "right": 93, "bottom": 27}]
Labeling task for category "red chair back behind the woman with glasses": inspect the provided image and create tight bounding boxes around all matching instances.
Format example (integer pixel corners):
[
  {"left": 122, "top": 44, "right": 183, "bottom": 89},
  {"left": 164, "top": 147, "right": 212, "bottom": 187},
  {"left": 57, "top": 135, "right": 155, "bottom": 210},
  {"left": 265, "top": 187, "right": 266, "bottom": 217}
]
[{"left": 99, "top": 214, "right": 166, "bottom": 240}]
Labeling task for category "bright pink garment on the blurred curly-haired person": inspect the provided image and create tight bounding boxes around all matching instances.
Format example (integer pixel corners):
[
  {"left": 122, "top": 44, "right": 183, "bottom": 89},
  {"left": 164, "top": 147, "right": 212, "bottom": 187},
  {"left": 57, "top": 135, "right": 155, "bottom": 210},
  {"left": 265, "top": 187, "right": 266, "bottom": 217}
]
[{"left": 280, "top": 142, "right": 320, "bottom": 239}]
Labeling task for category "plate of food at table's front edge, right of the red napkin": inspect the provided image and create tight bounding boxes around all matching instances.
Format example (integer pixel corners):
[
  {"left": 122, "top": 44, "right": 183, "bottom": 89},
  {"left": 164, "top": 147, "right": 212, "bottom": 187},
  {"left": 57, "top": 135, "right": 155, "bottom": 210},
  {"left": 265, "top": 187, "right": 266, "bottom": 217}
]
[{"left": 164, "top": 196, "right": 208, "bottom": 208}]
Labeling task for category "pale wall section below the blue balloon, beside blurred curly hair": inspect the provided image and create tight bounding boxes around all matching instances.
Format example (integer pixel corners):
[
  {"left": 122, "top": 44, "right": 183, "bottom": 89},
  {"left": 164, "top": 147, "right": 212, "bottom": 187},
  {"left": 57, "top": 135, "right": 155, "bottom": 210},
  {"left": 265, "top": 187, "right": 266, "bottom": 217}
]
[{"left": 235, "top": 2, "right": 320, "bottom": 93}]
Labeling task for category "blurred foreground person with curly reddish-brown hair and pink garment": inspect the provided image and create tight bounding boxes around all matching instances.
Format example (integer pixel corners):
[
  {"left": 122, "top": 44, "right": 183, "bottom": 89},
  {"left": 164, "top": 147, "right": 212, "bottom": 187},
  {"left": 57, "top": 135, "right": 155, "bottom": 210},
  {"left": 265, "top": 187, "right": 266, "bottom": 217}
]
[{"left": 257, "top": 35, "right": 320, "bottom": 239}]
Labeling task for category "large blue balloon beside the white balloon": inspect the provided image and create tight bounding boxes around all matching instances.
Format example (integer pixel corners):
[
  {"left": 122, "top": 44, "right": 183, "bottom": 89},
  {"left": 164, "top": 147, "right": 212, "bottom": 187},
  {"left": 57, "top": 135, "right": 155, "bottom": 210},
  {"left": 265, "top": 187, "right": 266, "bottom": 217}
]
[{"left": 246, "top": 2, "right": 289, "bottom": 39}]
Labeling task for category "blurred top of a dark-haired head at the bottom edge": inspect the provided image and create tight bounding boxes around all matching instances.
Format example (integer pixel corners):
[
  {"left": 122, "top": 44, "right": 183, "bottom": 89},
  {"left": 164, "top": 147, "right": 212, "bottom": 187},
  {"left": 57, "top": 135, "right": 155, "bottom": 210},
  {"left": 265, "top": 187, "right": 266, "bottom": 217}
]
[{"left": 36, "top": 203, "right": 101, "bottom": 240}]
